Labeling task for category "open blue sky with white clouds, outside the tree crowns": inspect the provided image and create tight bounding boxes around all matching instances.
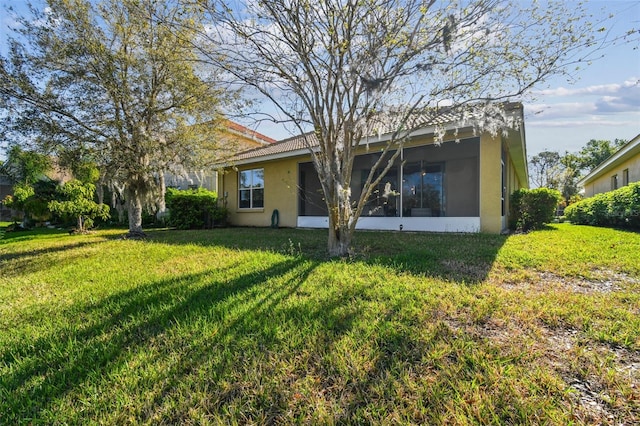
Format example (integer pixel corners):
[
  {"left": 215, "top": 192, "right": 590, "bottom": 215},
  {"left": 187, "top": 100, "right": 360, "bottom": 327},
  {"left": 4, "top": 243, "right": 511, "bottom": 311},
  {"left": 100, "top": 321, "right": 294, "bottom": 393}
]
[{"left": 0, "top": 0, "right": 640, "bottom": 157}]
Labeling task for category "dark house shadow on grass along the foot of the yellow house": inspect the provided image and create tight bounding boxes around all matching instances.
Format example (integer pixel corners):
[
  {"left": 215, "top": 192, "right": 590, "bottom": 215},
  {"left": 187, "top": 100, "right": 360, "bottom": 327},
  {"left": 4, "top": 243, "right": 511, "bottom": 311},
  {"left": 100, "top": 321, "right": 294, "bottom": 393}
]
[{"left": 150, "top": 228, "right": 508, "bottom": 284}]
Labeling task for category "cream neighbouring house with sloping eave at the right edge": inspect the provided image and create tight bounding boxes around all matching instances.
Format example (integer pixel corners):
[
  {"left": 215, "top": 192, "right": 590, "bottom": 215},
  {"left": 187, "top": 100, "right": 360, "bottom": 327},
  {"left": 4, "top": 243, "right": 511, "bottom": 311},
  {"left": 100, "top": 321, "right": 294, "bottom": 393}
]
[{"left": 578, "top": 135, "right": 640, "bottom": 197}]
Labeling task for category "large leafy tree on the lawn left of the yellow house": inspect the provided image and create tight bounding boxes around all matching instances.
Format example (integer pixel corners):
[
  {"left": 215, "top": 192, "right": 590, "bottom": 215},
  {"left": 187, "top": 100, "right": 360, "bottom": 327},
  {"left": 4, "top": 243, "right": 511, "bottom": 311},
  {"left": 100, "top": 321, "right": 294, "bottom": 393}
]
[{"left": 0, "top": 0, "right": 231, "bottom": 236}]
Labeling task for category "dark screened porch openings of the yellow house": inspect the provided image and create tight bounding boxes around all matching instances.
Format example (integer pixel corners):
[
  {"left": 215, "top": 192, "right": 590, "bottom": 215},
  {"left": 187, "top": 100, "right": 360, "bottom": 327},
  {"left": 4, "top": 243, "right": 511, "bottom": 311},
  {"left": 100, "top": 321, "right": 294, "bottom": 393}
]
[{"left": 298, "top": 138, "right": 478, "bottom": 218}]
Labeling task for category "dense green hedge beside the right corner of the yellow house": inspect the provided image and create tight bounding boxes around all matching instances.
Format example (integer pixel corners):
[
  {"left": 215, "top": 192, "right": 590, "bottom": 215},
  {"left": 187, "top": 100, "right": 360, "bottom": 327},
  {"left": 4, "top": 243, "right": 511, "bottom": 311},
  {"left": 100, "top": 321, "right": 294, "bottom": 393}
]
[{"left": 509, "top": 188, "right": 562, "bottom": 232}]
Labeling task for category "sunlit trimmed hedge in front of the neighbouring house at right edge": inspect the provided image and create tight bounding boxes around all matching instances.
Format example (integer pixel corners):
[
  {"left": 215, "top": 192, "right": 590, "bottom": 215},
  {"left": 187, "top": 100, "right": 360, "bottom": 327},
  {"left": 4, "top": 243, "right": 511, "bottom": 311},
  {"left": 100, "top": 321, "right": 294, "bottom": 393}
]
[{"left": 564, "top": 182, "right": 640, "bottom": 228}]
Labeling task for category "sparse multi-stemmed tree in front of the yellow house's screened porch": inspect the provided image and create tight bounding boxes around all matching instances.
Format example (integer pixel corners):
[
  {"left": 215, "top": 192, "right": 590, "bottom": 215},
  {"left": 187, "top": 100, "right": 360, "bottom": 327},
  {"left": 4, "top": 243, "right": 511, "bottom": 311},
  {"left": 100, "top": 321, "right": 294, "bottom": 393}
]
[{"left": 201, "top": 0, "right": 620, "bottom": 256}]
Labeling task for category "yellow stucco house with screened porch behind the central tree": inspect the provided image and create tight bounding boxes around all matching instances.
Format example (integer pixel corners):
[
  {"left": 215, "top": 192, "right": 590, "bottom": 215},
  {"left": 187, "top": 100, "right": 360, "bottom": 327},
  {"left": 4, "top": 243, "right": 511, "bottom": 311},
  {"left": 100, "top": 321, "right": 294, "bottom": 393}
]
[{"left": 218, "top": 104, "right": 528, "bottom": 233}]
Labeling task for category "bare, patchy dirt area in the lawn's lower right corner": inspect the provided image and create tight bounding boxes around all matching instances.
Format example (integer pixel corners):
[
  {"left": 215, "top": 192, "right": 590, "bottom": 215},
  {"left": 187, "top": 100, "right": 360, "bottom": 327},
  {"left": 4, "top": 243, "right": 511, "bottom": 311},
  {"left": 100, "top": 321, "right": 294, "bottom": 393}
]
[{"left": 441, "top": 312, "right": 640, "bottom": 426}]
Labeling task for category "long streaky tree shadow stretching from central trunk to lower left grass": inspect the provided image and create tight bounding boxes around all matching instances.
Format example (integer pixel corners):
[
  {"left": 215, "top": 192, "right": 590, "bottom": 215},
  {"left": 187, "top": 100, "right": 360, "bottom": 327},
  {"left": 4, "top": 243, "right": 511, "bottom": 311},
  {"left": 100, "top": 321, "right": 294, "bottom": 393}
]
[{"left": 0, "top": 255, "right": 314, "bottom": 424}]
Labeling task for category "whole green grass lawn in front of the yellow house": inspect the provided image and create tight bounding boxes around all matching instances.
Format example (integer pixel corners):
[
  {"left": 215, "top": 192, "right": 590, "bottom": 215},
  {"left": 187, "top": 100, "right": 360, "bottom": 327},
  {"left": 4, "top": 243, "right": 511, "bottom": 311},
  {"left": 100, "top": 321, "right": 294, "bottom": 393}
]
[{"left": 0, "top": 224, "right": 640, "bottom": 425}]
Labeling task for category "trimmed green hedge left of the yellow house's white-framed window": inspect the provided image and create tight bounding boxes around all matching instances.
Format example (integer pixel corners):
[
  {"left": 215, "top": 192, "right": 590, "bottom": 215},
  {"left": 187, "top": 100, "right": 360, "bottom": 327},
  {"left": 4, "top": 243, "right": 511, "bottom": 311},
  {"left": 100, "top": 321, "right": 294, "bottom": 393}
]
[{"left": 165, "top": 188, "right": 227, "bottom": 229}]
